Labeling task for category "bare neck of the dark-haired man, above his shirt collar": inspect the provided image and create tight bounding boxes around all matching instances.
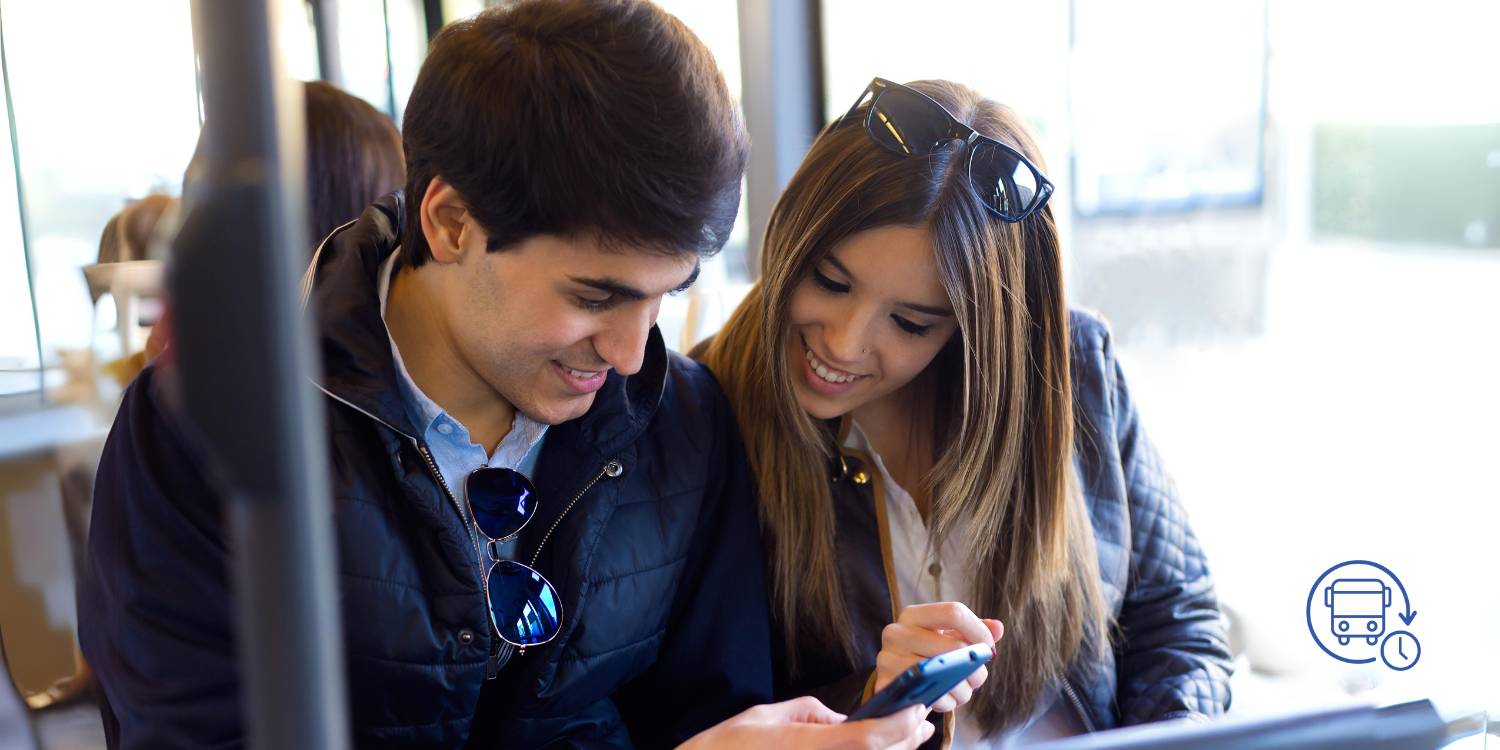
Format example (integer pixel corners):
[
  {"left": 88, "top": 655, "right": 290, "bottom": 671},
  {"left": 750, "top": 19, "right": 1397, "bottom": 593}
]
[{"left": 386, "top": 269, "right": 516, "bottom": 453}]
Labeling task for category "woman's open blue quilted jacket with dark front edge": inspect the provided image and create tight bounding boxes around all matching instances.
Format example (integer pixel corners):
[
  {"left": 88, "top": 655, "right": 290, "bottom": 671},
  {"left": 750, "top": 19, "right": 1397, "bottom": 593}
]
[{"left": 777, "top": 311, "right": 1232, "bottom": 744}]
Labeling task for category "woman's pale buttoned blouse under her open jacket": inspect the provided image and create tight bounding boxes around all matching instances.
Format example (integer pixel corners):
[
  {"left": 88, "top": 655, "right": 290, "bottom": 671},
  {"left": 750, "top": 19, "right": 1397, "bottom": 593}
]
[{"left": 845, "top": 423, "right": 1085, "bottom": 750}]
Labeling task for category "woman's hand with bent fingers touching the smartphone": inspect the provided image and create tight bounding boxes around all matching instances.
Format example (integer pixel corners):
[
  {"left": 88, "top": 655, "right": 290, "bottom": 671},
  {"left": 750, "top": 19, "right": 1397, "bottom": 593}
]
[{"left": 875, "top": 602, "right": 1005, "bottom": 711}]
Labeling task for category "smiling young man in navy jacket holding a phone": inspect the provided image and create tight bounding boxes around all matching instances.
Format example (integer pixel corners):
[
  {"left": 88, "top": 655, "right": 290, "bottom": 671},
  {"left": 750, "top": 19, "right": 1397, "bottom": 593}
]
[{"left": 80, "top": 0, "right": 810, "bottom": 749}]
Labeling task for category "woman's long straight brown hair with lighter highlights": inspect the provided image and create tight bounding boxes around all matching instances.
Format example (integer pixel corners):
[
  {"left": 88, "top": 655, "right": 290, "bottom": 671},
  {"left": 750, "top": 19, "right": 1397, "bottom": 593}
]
[{"left": 704, "top": 81, "right": 1109, "bottom": 732}]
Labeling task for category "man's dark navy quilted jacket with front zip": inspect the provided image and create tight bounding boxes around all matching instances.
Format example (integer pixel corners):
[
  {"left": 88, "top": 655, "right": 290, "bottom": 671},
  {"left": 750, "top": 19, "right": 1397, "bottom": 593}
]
[{"left": 80, "top": 197, "right": 771, "bottom": 749}]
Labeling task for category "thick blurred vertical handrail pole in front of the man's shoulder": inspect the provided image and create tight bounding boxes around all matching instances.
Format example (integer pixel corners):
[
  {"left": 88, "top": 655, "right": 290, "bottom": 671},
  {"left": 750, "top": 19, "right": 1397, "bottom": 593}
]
[{"left": 170, "top": 0, "right": 348, "bottom": 750}]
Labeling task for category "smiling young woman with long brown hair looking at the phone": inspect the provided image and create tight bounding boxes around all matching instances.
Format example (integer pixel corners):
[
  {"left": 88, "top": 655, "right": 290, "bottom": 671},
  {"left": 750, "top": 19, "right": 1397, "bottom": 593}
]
[{"left": 698, "top": 78, "right": 1230, "bottom": 747}]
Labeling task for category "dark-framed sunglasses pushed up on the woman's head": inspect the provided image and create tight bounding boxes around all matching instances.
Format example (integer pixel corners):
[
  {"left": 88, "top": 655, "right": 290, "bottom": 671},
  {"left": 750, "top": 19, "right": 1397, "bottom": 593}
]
[{"left": 834, "top": 78, "right": 1052, "bottom": 222}]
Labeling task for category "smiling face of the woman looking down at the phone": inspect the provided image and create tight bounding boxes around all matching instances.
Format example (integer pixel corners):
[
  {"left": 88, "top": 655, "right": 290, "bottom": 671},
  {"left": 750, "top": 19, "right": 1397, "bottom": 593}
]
[{"left": 786, "top": 227, "right": 959, "bottom": 419}]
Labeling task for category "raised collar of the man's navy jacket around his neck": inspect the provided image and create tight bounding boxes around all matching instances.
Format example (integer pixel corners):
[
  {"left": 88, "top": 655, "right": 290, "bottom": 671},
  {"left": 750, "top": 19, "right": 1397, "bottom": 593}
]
[{"left": 305, "top": 192, "right": 671, "bottom": 453}]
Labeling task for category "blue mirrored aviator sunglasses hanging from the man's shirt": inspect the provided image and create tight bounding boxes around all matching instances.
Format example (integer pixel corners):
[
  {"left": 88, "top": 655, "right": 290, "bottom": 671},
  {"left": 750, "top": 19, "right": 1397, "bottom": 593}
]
[{"left": 464, "top": 467, "right": 563, "bottom": 650}]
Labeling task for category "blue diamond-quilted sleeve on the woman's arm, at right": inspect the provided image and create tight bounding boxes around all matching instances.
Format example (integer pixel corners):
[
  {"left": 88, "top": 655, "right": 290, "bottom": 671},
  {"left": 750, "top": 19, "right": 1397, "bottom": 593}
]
[{"left": 1104, "top": 339, "right": 1232, "bottom": 726}]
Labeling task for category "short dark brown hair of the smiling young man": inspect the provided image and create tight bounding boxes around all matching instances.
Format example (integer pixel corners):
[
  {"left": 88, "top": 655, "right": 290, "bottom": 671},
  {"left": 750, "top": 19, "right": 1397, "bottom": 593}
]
[{"left": 402, "top": 0, "right": 749, "bottom": 267}]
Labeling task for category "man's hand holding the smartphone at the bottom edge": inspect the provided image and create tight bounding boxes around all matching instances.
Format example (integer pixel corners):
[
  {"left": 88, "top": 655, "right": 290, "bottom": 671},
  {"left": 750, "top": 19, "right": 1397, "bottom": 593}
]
[{"left": 678, "top": 698, "right": 933, "bottom": 750}]
